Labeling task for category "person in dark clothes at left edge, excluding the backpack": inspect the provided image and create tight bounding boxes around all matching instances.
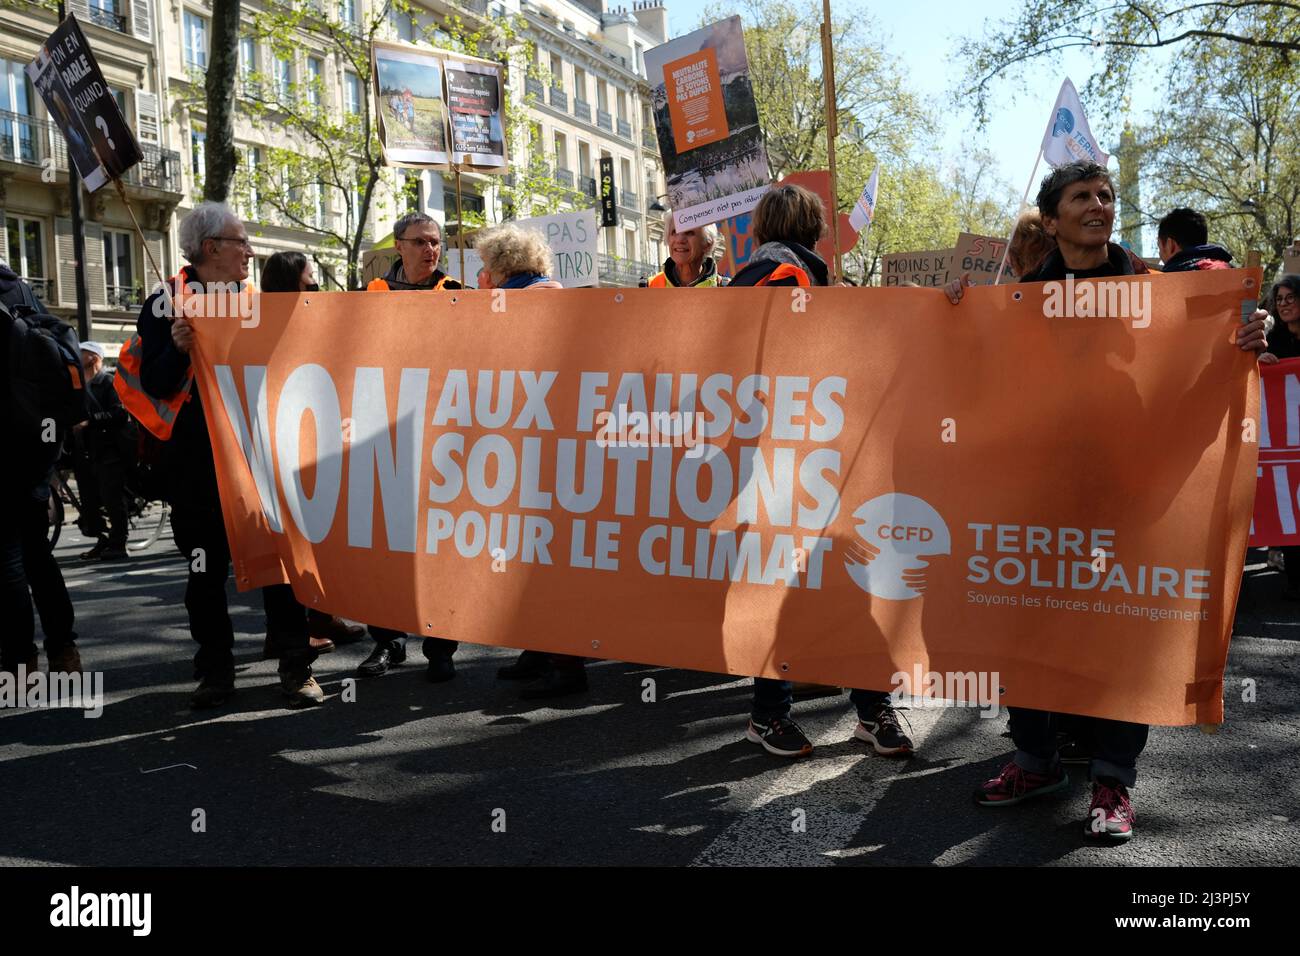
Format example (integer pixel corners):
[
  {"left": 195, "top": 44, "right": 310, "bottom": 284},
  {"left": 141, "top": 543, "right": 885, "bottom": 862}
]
[{"left": 0, "top": 263, "right": 82, "bottom": 674}]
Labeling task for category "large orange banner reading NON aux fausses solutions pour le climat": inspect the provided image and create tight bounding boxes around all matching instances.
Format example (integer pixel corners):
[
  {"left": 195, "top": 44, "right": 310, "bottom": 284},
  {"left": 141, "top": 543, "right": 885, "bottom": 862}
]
[{"left": 189, "top": 271, "right": 1260, "bottom": 724}]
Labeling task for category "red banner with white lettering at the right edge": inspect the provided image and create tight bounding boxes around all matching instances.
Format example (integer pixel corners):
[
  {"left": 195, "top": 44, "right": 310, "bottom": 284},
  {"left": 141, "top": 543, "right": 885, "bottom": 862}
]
[{"left": 1243, "top": 359, "right": 1300, "bottom": 548}]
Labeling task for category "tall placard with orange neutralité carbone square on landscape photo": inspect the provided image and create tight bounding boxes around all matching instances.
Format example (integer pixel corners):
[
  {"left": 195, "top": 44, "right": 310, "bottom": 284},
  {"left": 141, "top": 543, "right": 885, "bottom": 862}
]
[{"left": 645, "top": 17, "right": 771, "bottom": 230}]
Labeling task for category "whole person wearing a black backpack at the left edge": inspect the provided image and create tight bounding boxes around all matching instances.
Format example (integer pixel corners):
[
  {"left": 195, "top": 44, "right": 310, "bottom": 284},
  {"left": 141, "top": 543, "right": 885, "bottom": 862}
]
[{"left": 0, "top": 254, "right": 86, "bottom": 674}]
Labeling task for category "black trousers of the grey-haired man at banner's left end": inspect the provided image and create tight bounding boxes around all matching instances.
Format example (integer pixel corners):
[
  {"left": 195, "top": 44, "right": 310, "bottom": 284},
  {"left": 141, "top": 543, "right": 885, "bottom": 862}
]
[{"left": 172, "top": 497, "right": 316, "bottom": 678}]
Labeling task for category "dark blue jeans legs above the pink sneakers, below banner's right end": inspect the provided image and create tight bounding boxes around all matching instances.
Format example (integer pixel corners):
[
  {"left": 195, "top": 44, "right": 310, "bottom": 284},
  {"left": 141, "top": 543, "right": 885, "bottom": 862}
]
[{"left": 1008, "top": 708, "right": 1151, "bottom": 787}]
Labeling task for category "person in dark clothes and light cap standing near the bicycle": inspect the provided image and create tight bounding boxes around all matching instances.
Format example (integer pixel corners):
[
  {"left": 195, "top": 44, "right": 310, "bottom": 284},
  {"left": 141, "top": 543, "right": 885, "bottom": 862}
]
[{"left": 74, "top": 342, "right": 135, "bottom": 561}]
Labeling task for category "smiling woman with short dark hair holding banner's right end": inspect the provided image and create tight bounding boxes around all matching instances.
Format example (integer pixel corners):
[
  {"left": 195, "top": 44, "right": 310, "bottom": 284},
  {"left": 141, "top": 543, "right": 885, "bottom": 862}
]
[{"left": 946, "top": 161, "right": 1268, "bottom": 842}]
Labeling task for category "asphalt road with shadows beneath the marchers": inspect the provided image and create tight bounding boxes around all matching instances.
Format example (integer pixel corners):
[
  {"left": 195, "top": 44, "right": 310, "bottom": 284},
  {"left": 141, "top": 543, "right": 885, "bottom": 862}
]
[{"left": 0, "top": 509, "right": 1300, "bottom": 866}]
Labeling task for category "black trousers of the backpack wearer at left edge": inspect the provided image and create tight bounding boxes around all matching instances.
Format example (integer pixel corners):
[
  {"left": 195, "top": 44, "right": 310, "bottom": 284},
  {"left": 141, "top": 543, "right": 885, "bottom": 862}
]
[{"left": 0, "top": 492, "right": 77, "bottom": 671}]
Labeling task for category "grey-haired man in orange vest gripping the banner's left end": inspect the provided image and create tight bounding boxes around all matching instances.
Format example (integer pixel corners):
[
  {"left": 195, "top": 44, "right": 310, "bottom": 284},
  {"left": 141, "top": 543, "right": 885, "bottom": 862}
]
[{"left": 126, "top": 202, "right": 325, "bottom": 708}]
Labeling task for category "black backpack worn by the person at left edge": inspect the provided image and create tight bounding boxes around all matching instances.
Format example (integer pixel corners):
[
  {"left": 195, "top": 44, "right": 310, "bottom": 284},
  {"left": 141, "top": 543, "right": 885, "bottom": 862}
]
[{"left": 0, "top": 282, "right": 87, "bottom": 485}]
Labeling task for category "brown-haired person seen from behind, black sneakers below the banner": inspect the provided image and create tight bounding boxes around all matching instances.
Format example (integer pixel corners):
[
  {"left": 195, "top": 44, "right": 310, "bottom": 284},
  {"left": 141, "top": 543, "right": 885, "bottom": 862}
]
[{"left": 732, "top": 185, "right": 914, "bottom": 757}]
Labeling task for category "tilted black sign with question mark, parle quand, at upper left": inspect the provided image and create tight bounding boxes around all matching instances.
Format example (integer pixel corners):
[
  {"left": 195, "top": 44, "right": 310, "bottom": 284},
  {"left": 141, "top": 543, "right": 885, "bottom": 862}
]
[{"left": 27, "top": 14, "right": 143, "bottom": 193}]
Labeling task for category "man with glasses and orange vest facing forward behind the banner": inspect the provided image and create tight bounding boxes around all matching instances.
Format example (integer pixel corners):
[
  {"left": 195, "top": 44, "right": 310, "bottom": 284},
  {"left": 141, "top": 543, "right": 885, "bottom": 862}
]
[{"left": 356, "top": 212, "right": 464, "bottom": 684}]
